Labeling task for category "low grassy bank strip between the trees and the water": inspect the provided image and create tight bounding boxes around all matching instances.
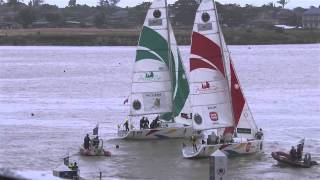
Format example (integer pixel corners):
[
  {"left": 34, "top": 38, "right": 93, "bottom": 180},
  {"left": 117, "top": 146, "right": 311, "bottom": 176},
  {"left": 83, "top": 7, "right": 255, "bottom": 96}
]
[{"left": 0, "top": 28, "right": 320, "bottom": 46}]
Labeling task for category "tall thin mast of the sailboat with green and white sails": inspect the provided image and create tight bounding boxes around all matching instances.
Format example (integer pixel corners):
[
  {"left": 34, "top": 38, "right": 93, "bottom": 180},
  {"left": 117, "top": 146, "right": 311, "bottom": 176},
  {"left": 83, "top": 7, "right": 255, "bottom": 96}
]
[{"left": 165, "top": 0, "right": 174, "bottom": 121}]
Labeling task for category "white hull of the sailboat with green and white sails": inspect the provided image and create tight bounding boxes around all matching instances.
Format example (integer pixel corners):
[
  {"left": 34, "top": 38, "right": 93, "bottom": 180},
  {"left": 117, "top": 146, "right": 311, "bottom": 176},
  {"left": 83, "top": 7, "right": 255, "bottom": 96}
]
[{"left": 118, "top": 126, "right": 193, "bottom": 140}]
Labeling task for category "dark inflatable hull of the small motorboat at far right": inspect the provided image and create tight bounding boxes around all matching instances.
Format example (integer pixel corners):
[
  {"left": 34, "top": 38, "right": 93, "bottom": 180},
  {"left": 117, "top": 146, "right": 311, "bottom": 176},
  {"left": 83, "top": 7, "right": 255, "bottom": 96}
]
[{"left": 271, "top": 151, "right": 318, "bottom": 168}]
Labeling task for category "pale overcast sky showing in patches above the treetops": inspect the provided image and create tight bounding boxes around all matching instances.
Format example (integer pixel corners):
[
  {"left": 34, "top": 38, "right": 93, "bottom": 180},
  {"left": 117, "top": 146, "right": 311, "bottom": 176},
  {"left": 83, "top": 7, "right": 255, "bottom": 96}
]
[{"left": 43, "top": 0, "right": 320, "bottom": 8}]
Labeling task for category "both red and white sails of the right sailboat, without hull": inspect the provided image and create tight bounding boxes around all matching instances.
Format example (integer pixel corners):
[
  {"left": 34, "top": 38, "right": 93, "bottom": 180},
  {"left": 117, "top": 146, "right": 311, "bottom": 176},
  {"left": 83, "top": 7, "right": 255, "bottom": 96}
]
[{"left": 190, "top": 0, "right": 258, "bottom": 137}]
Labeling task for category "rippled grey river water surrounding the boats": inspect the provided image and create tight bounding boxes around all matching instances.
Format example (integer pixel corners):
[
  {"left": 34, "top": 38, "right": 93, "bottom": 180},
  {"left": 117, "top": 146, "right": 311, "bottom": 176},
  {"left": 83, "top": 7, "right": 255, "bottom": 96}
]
[{"left": 0, "top": 44, "right": 320, "bottom": 180}]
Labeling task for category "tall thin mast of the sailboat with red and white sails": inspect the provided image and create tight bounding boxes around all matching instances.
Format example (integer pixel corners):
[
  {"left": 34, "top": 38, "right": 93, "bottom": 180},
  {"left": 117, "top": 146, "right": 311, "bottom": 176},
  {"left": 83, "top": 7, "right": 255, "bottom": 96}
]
[{"left": 213, "top": 1, "right": 235, "bottom": 131}]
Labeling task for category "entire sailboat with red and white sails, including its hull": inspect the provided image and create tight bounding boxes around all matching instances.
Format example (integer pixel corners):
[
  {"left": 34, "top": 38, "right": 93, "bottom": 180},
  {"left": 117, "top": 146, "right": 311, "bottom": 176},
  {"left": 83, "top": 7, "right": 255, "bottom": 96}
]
[{"left": 182, "top": 0, "right": 263, "bottom": 158}]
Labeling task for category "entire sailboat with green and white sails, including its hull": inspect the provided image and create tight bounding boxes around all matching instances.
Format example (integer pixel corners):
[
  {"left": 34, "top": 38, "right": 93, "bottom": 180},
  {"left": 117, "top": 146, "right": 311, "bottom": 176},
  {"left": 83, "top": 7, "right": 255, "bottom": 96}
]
[{"left": 118, "top": 0, "right": 192, "bottom": 139}]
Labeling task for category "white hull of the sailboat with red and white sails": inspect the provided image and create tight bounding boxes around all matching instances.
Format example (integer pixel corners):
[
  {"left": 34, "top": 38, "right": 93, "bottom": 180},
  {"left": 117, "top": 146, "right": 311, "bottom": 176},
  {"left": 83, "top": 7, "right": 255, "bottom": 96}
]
[{"left": 182, "top": 139, "right": 263, "bottom": 158}]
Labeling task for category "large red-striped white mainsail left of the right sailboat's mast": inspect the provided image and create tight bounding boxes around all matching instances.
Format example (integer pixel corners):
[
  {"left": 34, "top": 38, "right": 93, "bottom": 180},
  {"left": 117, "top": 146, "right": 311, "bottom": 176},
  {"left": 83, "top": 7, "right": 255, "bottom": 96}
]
[{"left": 190, "top": 0, "right": 234, "bottom": 130}]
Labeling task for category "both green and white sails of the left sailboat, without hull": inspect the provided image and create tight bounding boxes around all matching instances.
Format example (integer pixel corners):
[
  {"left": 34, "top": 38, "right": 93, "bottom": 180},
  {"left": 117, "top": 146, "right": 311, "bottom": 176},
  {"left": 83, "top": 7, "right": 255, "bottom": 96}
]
[{"left": 130, "top": 0, "right": 189, "bottom": 124}]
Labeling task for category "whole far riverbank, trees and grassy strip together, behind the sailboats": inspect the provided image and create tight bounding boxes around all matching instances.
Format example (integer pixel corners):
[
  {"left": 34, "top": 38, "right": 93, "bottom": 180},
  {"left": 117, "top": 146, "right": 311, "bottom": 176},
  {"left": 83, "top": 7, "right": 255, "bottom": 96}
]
[{"left": 0, "top": 0, "right": 320, "bottom": 45}]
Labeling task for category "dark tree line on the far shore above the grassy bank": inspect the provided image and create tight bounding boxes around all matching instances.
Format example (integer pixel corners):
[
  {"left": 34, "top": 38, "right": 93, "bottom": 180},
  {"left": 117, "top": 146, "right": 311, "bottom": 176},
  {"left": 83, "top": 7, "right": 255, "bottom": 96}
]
[{"left": 0, "top": 0, "right": 316, "bottom": 29}]
